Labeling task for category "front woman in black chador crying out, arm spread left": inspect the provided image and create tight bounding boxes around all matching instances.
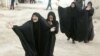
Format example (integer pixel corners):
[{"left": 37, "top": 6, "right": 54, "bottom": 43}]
[{"left": 8, "top": 13, "right": 50, "bottom": 56}]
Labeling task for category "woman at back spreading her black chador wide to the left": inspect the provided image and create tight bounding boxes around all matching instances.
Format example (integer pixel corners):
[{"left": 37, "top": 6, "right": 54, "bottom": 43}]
[{"left": 58, "top": 2, "right": 77, "bottom": 43}]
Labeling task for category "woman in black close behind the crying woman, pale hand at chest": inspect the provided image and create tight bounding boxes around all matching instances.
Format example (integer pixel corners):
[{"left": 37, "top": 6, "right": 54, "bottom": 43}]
[{"left": 47, "top": 12, "right": 59, "bottom": 56}]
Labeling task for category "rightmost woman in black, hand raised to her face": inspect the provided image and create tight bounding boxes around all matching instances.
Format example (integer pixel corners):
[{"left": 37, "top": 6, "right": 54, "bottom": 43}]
[{"left": 85, "top": 2, "right": 94, "bottom": 42}]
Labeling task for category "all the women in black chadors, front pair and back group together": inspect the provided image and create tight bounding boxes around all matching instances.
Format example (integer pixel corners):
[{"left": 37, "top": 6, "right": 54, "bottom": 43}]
[{"left": 8, "top": 2, "right": 94, "bottom": 56}]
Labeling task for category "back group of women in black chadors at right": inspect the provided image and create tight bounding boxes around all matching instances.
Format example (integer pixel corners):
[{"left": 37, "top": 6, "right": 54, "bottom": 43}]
[{"left": 58, "top": 2, "right": 94, "bottom": 43}]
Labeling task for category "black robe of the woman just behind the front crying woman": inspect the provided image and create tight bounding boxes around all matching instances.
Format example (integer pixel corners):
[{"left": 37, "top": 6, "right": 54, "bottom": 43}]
[{"left": 47, "top": 21, "right": 59, "bottom": 56}]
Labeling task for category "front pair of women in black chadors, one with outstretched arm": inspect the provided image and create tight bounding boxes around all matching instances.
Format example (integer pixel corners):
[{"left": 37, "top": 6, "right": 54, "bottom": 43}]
[{"left": 10, "top": 11, "right": 59, "bottom": 56}]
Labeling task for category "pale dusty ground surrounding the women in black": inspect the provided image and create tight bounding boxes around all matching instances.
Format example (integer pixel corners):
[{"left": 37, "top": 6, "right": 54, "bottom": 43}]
[{"left": 0, "top": 2, "right": 100, "bottom": 56}]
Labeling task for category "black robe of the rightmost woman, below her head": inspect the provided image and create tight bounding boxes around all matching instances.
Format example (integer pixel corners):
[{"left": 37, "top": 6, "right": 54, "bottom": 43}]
[{"left": 86, "top": 8, "right": 94, "bottom": 41}]
